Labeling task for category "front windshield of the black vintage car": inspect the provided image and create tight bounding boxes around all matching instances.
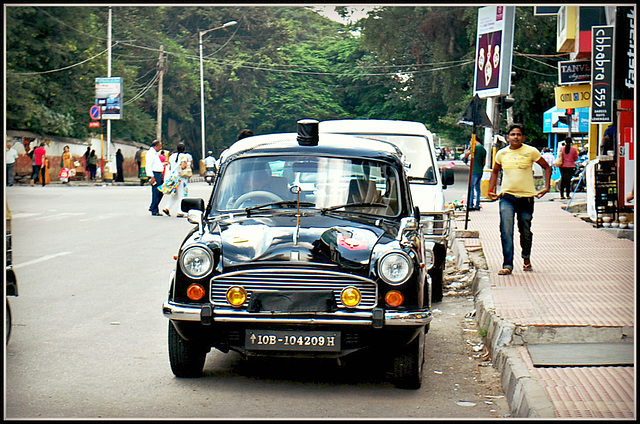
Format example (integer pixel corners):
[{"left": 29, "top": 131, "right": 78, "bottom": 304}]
[{"left": 212, "top": 156, "right": 402, "bottom": 216}]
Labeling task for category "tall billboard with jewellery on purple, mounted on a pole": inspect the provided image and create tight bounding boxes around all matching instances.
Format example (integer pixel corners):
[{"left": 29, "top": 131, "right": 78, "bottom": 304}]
[{"left": 473, "top": 6, "right": 516, "bottom": 99}]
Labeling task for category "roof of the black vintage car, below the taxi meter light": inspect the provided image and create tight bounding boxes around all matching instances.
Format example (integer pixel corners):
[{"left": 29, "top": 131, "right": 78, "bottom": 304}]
[{"left": 220, "top": 133, "right": 402, "bottom": 163}]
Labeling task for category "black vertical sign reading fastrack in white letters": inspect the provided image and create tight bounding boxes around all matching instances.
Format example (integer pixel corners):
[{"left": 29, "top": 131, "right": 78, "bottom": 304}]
[{"left": 613, "top": 6, "right": 636, "bottom": 100}]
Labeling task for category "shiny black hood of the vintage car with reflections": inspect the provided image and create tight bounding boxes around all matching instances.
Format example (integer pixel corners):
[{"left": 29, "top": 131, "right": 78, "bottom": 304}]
[{"left": 213, "top": 215, "right": 393, "bottom": 273}]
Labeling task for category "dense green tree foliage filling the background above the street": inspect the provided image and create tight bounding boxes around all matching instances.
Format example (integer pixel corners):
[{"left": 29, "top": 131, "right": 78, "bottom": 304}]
[{"left": 5, "top": 5, "right": 559, "bottom": 157}]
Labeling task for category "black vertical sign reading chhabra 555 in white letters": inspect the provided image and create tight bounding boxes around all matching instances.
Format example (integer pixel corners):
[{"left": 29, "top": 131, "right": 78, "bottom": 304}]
[{"left": 591, "top": 26, "right": 613, "bottom": 124}]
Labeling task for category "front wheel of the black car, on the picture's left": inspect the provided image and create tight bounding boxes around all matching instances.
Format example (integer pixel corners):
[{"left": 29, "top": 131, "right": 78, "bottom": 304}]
[{"left": 169, "top": 321, "right": 207, "bottom": 378}]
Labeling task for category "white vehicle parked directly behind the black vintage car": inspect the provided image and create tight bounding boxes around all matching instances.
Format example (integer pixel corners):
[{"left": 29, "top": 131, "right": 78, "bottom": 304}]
[{"left": 319, "top": 119, "right": 454, "bottom": 302}]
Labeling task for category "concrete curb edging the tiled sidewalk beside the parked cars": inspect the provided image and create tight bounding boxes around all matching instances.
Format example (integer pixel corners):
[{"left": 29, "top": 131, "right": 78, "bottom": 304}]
[{"left": 472, "top": 269, "right": 556, "bottom": 418}]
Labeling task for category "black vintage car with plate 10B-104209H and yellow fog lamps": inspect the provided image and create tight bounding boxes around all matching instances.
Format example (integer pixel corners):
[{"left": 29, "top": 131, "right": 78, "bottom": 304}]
[{"left": 163, "top": 120, "right": 433, "bottom": 389}]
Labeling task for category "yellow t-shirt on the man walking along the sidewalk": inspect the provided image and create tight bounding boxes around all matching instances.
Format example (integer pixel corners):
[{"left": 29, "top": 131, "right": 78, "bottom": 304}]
[{"left": 495, "top": 144, "right": 542, "bottom": 197}]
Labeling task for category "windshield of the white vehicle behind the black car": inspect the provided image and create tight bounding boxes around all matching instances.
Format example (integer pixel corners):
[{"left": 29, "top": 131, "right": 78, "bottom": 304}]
[{"left": 355, "top": 134, "right": 437, "bottom": 184}]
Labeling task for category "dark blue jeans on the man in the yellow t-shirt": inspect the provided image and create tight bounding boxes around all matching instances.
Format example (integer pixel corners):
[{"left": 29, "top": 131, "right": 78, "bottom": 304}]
[{"left": 500, "top": 194, "right": 533, "bottom": 270}]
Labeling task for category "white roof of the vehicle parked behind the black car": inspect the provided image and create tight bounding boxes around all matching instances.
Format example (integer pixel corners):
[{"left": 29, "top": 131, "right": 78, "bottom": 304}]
[{"left": 319, "top": 119, "right": 432, "bottom": 136}]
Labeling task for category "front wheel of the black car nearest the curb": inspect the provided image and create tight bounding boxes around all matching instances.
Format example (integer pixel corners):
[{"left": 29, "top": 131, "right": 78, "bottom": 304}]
[{"left": 393, "top": 331, "right": 425, "bottom": 390}]
